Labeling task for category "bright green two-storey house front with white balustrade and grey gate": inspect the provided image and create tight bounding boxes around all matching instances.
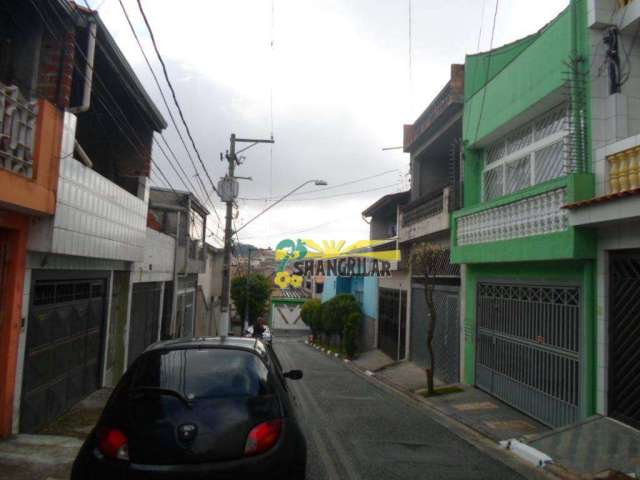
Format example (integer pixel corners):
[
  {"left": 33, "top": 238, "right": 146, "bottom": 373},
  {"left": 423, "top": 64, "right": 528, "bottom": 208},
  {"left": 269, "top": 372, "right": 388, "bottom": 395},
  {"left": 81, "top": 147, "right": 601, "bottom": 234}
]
[{"left": 451, "top": 0, "right": 597, "bottom": 426}]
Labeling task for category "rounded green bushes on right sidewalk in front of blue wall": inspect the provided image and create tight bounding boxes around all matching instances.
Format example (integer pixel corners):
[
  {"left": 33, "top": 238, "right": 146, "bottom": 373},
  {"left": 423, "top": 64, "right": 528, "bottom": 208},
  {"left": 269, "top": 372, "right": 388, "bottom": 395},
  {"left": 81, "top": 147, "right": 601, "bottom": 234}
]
[{"left": 301, "top": 293, "right": 362, "bottom": 357}]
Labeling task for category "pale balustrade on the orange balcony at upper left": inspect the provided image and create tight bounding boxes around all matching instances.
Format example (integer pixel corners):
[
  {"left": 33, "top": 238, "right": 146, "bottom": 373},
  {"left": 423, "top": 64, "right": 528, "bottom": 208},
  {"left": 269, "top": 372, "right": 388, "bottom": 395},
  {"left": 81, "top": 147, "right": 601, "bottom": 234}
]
[{"left": 0, "top": 83, "right": 38, "bottom": 178}]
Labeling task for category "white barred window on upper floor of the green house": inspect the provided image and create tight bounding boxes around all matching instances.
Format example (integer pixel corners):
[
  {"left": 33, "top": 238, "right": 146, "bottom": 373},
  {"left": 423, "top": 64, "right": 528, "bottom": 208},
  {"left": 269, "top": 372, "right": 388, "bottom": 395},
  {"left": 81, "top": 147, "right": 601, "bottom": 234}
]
[{"left": 482, "top": 105, "right": 571, "bottom": 201}]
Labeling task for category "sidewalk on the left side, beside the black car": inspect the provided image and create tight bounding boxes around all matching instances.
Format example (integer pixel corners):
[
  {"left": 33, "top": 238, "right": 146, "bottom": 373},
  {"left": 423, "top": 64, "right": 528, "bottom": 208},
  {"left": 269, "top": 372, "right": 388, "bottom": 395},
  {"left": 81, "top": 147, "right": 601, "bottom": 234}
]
[{"left": 0, "top": 388, "right": 111, "bottom": 480}]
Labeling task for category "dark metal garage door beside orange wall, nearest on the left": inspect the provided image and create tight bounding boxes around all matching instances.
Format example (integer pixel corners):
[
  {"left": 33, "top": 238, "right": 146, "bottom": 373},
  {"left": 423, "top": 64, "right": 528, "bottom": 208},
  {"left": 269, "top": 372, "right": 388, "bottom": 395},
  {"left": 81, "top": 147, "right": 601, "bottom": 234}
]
[{"left": 20, "top": 279, "right": 105, "bottom": 432}]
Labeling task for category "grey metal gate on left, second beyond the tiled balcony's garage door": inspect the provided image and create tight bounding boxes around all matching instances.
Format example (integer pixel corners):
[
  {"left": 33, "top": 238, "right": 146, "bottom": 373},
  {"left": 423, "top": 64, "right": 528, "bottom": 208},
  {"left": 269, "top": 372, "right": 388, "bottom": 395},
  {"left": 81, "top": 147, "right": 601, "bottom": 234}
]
[{"left": 127, "top": 282, "right": 162, "bottom": 365}]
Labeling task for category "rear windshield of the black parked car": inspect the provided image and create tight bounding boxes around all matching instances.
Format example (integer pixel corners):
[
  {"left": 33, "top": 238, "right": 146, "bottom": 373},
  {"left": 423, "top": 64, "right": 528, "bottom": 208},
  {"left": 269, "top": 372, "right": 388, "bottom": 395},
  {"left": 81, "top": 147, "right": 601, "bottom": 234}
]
[{"left": 132, "top": 348, "right": 272, "bottom": 400}]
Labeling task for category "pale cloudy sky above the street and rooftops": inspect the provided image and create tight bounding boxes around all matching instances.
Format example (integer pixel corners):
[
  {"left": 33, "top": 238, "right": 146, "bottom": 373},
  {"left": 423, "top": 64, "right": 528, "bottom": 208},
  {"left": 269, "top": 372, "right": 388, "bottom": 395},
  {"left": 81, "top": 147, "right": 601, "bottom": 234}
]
[{"left": 90, "top": 0, "right": 568, "bottom": 246}]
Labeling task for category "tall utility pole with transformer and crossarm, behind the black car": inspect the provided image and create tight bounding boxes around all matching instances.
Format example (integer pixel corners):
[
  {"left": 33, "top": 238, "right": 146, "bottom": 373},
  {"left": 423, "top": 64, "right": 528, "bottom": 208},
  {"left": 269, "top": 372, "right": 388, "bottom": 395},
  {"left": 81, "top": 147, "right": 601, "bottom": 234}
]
[{"left": 218, "top": 133, "right": 274, "bottom": 336}]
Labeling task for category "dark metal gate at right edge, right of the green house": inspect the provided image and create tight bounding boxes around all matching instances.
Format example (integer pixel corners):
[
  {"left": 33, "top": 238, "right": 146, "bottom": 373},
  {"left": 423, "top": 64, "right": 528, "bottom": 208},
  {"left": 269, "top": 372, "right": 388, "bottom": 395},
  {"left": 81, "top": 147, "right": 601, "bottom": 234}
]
[{"left": 609, "top": 251, "right": 640, "bottom": 428}]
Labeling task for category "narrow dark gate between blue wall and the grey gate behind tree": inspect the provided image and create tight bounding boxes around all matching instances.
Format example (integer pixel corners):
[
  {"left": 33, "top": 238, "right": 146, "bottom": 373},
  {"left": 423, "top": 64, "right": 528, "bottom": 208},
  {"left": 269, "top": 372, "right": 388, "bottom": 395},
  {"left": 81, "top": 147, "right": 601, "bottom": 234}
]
[{"left": 378, "top": 288, "right": 407, "bottom": 360}]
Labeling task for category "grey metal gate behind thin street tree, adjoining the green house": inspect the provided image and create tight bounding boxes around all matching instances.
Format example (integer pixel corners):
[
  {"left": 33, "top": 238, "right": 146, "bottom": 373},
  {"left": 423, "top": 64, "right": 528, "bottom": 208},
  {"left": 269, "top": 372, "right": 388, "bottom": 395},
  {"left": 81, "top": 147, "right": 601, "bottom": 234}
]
[{"left": 411, "top": 284, "right": 460, "bottom": 383}]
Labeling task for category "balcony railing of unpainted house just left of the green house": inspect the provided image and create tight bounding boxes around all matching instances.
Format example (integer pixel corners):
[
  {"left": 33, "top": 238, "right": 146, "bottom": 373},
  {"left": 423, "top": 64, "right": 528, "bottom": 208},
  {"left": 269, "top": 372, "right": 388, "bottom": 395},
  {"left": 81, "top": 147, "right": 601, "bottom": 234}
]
[{"left": 398, "top": 187, "right": 454, "bottom": 242}]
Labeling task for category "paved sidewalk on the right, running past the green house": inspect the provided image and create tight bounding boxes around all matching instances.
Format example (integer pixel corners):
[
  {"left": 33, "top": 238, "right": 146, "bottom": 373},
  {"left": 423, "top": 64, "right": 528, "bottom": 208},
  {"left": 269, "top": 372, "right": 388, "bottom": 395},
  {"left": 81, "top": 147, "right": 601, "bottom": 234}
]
[{"left": 349, "top": 344, "right": 640, "bottom": 480}]
